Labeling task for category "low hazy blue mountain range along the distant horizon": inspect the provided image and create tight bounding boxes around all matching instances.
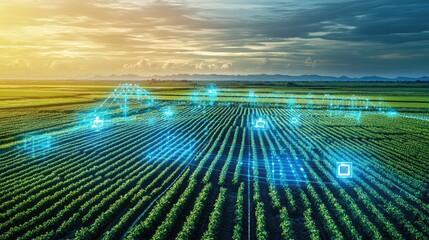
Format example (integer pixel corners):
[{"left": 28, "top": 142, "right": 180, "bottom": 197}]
[{"left": 90, "top": 74, "right": 429, "bottom": 82}]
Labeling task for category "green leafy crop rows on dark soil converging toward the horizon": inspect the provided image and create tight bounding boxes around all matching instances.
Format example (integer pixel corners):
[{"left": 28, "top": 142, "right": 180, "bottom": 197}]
[{"left": 0, "top": 86, "right": 429, "bottom": 240}]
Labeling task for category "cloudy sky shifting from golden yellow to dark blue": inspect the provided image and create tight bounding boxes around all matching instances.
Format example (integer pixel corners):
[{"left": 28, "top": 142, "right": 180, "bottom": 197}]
[{"left": 0, "top": 0, "right": 429, "bottom": 78}]
